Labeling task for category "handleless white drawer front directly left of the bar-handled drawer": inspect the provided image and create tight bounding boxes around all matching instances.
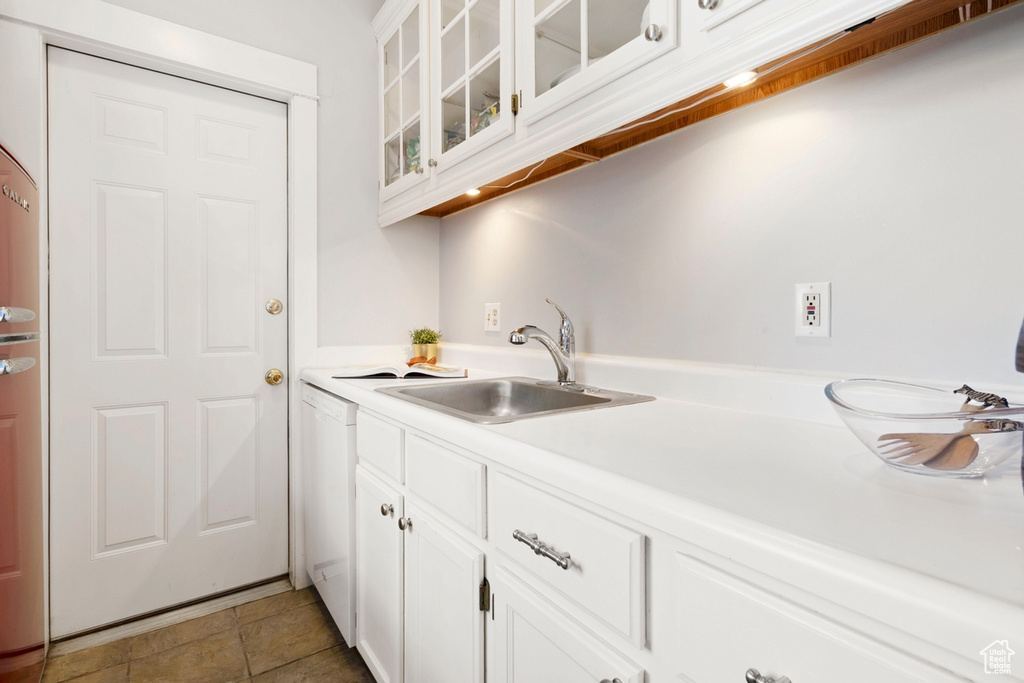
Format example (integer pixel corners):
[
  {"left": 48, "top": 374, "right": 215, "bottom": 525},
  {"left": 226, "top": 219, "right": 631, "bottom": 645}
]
[{"left": 406, "top": 434, "right": 486, "bottom": 538}]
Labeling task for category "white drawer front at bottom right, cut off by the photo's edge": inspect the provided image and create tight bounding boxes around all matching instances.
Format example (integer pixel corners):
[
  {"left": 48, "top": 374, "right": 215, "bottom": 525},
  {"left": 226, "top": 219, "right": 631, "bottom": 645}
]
[{"left": 673, "top": 553, "right": 962, "bottom": 683}]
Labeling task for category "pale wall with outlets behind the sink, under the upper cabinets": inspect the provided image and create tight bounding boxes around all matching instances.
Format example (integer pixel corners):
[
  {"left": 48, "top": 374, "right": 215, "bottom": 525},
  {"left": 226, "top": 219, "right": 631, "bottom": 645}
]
[{"left": 440, "top": 6, "right": 1024, "bottom": 383}]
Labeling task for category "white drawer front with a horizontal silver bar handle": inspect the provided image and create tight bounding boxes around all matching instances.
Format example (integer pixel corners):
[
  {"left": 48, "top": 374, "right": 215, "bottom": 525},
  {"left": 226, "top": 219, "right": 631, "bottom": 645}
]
[{"left": 489, "top": 474, "right": 645, "bottom": 647}]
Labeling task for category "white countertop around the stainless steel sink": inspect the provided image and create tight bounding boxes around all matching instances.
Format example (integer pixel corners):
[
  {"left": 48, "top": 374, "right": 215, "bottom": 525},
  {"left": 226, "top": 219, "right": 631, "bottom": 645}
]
[{"left": 302, "top": 369, "right": 1024, "bottom": 626}]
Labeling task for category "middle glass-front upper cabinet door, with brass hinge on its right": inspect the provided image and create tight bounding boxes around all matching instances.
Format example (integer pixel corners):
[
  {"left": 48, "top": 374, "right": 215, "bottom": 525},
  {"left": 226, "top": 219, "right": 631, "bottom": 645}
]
[{"left": 430, "top": 0, "right": 514, "bottom": 170}]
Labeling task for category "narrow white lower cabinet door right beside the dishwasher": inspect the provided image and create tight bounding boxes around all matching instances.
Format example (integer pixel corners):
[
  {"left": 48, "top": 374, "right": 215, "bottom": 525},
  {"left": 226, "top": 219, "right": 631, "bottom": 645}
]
[{"left": 355, "top": 466, "right": 403, "bottom": 683}]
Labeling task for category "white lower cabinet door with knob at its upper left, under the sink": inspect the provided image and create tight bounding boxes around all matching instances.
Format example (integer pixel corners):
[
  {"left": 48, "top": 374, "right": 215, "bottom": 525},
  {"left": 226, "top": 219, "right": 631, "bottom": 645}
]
[{"left": 406, "top": 505, "right": 484, "bottom": 683}]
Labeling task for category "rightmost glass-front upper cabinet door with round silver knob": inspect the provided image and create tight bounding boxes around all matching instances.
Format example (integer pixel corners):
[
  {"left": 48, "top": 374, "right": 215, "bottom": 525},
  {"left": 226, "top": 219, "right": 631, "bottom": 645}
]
[{"left": 516, "top": 0, "right": 679, "bottom": 123}]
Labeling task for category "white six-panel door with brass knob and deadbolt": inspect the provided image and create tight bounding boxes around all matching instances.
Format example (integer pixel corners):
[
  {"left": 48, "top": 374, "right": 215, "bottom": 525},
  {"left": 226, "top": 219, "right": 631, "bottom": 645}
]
[{"left": 49, "top": 48, "right": 288, "bottom": 637}]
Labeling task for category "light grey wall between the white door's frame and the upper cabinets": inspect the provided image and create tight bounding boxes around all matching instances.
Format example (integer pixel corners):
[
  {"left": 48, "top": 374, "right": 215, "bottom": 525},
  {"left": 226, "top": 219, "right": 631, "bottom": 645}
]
[{"left": 100, "top": 0, "right": 438, "bottom": 346}]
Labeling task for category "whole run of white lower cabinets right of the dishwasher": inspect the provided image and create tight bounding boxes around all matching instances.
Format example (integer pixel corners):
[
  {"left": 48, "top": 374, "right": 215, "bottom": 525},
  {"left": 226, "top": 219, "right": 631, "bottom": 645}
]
[{"left": 337, "top": 395, "right": 999, "bottom": 683}]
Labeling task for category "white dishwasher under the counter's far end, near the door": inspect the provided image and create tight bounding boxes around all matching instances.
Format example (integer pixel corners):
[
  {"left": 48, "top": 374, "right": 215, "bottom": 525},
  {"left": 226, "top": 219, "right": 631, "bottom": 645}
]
[{"left": 302, "top": 383, "right": 356, "bottom": 646}]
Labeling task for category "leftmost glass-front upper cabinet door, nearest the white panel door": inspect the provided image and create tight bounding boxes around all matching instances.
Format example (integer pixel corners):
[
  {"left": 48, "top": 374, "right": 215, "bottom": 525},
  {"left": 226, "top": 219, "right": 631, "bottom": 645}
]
[{"left": 378, "top": 0, "right": 429, "bottom": 197}]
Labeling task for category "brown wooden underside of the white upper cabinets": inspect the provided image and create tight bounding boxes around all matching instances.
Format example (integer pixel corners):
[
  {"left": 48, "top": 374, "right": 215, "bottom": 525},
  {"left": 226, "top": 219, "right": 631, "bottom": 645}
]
[{"left": 421, "top": 0, "right": 1024, "bottom": 218}]
